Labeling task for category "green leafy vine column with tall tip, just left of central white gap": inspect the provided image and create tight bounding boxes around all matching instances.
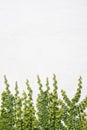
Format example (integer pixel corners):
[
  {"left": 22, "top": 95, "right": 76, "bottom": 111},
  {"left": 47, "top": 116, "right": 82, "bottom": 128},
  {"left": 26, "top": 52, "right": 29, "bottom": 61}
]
[{"left": 23, "top": 80, "right": 36, "bottom": 130}]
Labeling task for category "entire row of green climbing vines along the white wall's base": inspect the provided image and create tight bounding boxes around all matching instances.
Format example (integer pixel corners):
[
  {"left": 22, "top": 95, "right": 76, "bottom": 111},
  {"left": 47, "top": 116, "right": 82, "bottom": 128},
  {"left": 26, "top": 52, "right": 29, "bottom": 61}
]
[{"left": 0, "top": 74, "right": 87, "bottom": 130}]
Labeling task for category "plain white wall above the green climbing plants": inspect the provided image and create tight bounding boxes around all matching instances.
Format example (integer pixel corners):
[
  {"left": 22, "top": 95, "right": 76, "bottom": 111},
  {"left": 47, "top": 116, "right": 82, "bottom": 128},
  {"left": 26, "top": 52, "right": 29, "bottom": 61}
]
[{"left": 0, "top": 0, "right": 87, "bottom": 101}]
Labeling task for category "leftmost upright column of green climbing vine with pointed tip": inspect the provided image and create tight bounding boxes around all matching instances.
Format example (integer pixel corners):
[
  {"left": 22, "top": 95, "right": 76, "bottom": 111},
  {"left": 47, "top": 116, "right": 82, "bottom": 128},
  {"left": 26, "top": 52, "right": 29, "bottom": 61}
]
[{"left": 0, "top": 76, "right": 15, "bottom": 130}]
